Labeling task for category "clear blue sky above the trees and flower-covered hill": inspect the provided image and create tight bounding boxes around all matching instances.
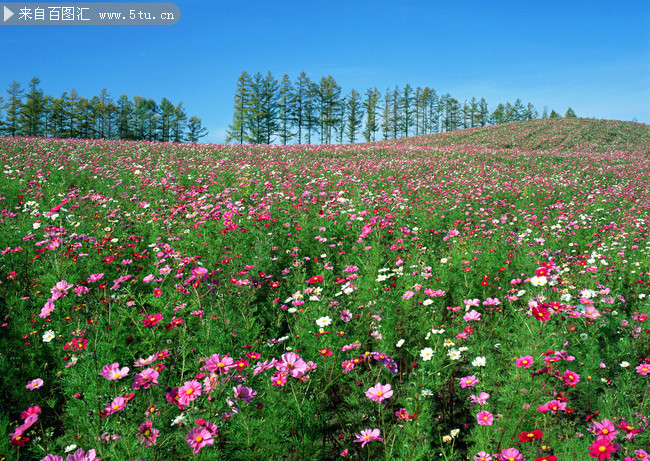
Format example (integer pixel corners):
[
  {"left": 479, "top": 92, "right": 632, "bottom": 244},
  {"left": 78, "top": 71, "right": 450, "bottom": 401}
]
[{"left": 0, "top": 0, "right": 650, "bottom": 142}]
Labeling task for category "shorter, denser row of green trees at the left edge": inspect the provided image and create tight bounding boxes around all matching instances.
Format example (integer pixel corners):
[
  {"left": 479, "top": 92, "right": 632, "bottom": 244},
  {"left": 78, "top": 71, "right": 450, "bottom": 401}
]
[{"left": 0, "top": 77, "right": 207, "bottom": 142}]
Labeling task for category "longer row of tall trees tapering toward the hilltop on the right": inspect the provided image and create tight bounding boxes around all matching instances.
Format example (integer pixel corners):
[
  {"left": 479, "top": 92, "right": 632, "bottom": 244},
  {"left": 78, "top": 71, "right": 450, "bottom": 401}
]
[{"left": 226, "top": 71, "right": 575, "bottom": 144}]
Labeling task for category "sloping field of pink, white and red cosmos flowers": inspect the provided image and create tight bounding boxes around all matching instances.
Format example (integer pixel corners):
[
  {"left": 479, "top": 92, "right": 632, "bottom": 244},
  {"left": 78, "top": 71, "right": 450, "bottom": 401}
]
[{"left": 0, "top": 119, "right": 650, "bottom": 461}]
